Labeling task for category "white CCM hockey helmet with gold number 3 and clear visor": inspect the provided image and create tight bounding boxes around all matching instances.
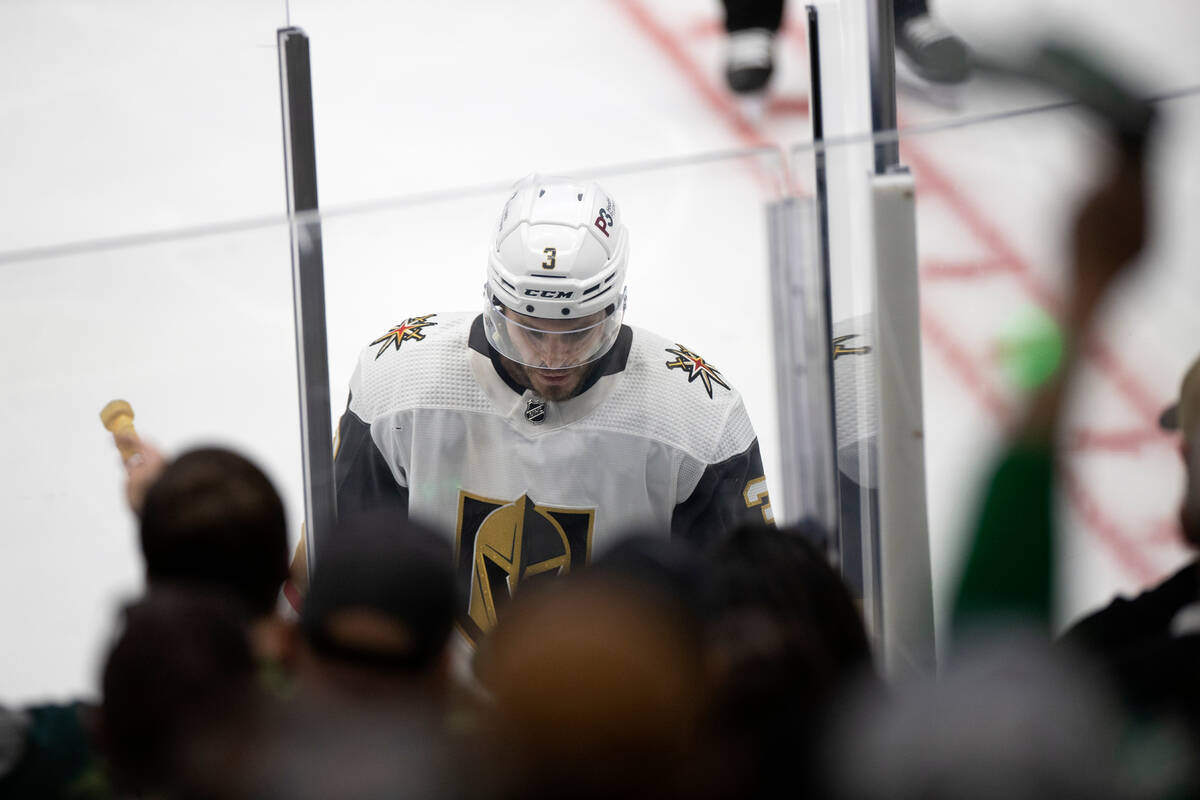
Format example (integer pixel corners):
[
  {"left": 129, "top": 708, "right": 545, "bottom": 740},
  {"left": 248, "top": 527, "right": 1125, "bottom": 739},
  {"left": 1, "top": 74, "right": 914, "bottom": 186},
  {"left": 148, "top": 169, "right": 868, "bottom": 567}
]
[{"left": 484, "top": 175, "right": 629, "bottom": 369}]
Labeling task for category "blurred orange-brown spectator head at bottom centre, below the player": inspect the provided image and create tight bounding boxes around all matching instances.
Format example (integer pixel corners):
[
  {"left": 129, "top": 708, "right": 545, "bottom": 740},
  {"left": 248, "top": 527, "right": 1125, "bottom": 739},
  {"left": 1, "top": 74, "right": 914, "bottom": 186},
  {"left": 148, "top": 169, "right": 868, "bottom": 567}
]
[{"left": 476, "top": 575, "right": 704, "bottom": 798}]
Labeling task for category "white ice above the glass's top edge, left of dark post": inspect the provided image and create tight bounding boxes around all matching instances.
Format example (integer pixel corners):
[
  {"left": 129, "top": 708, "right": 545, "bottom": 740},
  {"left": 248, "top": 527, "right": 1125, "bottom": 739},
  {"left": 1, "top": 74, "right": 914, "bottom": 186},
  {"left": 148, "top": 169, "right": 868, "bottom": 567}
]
[{"left": 0, "top": 0, "right": 286, "bottom": 251}]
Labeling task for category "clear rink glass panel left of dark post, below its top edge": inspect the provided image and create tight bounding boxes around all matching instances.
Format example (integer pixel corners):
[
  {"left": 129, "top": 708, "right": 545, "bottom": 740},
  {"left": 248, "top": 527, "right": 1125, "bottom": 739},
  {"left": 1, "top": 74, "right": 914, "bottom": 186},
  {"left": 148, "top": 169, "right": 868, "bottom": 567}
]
[{"left": 0, "top": 223, "right": 302, "bottom": 700}]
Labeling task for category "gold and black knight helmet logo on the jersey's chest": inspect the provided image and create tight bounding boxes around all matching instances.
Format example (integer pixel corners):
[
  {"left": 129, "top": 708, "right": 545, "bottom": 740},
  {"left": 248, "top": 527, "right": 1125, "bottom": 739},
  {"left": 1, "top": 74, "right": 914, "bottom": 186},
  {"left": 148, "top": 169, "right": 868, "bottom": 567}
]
[{"left": 455, "top": 491, "right": 595, "bottom": 642}]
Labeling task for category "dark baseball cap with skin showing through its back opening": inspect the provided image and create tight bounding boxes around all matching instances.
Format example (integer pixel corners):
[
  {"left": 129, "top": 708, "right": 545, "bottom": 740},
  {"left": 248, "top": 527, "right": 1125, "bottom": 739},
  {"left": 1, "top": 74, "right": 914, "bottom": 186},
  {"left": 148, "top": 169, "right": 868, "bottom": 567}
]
[{"left": 300, "top": 515, "right": 455, "bottom": 672}]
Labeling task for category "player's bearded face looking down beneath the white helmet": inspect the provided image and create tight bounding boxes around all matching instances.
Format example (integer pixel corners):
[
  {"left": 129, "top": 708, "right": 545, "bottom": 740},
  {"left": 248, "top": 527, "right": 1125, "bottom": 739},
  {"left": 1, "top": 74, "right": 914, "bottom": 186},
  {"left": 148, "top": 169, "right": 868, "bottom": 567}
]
[{"left": 504, "top": 309, "right": 605, "bottom": 401}]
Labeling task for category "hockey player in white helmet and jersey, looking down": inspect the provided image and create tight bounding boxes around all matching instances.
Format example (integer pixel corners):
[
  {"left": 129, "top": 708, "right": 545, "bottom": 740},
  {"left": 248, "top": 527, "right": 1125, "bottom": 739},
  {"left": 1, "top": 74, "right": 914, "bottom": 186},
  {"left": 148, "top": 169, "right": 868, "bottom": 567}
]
[{"left": 296, "top": 176, "right": 773, "bottom": 640}]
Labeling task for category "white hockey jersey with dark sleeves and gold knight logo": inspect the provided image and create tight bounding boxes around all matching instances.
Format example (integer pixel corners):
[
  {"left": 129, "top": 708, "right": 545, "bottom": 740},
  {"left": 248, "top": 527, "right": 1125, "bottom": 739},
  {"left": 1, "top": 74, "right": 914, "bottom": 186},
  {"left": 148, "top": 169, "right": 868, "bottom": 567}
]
[{"left": 335, "top": 313, "right": 773, "bottom": 640}]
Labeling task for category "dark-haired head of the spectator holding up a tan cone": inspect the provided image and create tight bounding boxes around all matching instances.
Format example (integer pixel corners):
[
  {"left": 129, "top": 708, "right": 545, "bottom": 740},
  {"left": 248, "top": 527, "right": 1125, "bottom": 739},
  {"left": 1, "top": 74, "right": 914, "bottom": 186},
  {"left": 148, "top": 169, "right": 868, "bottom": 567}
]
[{"left": 142, "top": 447, "right": 288, "bottom": 615}]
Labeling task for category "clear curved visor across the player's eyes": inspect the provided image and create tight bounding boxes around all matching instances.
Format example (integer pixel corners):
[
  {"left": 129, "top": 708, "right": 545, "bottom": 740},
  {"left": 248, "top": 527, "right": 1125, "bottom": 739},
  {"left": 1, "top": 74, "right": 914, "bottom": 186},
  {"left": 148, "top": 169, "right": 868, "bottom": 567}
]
[{"left": 484, "top": 290, "right": 625, "bottom": 369}]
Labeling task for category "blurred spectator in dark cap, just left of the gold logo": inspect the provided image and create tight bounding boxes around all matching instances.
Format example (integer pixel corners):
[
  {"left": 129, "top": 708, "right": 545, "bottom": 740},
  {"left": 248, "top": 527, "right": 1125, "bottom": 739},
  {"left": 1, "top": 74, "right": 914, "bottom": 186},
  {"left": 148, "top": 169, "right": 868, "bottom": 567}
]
[{"left": 247, "top": 516, "right": 457, "bottom": 800}]
